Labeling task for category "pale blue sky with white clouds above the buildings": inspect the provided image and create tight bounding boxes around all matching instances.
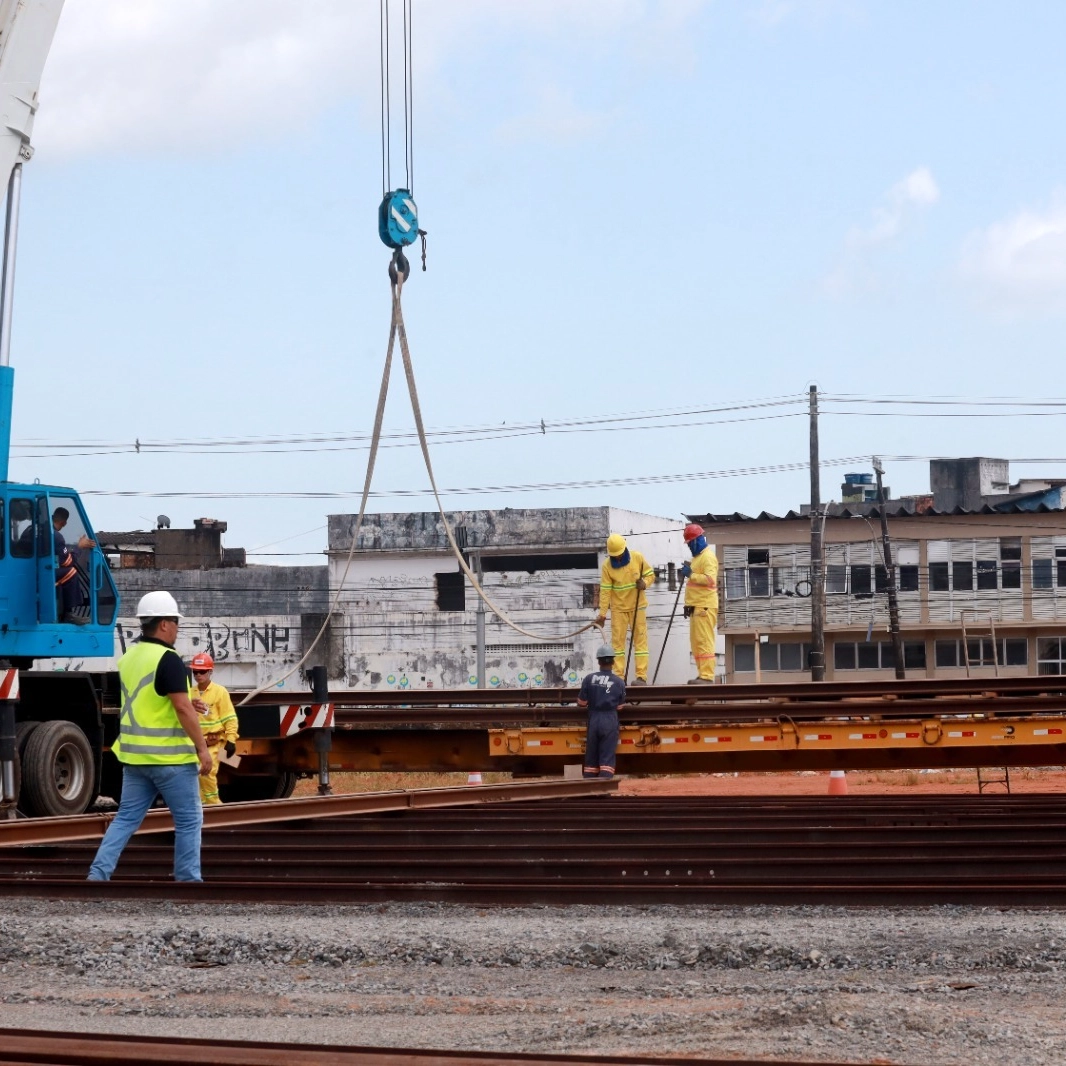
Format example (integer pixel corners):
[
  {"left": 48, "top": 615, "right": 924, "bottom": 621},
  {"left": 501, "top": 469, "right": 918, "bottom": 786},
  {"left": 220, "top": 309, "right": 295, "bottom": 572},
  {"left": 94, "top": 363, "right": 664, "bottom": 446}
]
[{"left": 12, "top": 0, "right": 1066, "bottom": 562}]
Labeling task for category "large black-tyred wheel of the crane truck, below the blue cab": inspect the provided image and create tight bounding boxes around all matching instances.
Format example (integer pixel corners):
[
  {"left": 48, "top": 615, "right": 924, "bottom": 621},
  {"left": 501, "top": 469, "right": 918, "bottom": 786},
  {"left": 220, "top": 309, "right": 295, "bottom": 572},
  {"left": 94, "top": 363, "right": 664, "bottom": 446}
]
[{"left": 22, "top": 722, "right": 95, "bottom": 817}]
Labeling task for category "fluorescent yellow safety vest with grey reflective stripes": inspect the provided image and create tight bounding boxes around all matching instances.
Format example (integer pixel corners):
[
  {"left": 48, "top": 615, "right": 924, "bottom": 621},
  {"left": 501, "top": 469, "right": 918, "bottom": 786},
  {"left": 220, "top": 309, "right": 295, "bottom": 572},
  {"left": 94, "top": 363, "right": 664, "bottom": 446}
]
[{"left": 111, "top": 642, "right": 199, "bottom": 765}]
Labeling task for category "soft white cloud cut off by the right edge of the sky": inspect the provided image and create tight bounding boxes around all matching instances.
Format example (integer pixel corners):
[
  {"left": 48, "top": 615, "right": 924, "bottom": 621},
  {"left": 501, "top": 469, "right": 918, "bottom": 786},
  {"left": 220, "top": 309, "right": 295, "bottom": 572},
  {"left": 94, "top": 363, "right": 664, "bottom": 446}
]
[{"left": 959, "top": 193, "right": 1066, "bottom": 310}]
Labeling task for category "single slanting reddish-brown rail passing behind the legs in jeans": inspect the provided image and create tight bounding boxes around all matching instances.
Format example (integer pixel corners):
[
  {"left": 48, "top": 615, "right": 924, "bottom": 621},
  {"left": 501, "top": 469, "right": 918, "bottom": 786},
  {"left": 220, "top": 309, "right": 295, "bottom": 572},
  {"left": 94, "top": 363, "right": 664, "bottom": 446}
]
[{"left": 0, "top": 780, "right": 618, "bottom": 847}]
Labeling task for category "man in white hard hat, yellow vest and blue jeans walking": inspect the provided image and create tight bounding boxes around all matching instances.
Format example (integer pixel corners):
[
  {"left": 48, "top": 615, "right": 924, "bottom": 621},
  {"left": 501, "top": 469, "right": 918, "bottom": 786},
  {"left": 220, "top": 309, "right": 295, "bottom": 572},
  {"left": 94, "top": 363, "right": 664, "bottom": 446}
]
[{"left": 88, "top": 592, "right": 212, "bottom": 881}]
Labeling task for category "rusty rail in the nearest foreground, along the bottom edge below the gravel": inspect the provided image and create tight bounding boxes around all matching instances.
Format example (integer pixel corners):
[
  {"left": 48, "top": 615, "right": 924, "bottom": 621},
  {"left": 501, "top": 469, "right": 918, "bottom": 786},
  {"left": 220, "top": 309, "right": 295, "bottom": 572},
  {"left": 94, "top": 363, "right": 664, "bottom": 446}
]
[{"left": 0, "top": 1029, "right": 878, "bottom": 1066}]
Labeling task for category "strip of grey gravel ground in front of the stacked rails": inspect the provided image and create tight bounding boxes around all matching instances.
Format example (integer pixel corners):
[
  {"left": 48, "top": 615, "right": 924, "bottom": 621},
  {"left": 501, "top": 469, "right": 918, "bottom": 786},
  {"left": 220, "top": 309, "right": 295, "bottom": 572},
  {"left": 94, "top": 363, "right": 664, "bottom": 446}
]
[{"left": 0, "top": 900, "right": 1066, "bottom": 1066}]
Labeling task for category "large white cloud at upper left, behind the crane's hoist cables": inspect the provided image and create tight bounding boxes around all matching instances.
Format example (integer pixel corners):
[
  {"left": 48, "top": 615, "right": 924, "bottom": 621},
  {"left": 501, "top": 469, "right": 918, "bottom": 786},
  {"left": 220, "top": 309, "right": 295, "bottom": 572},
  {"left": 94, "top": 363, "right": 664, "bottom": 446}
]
[{"left": 34, "top": 0, "right": 708, "bottom": 158}]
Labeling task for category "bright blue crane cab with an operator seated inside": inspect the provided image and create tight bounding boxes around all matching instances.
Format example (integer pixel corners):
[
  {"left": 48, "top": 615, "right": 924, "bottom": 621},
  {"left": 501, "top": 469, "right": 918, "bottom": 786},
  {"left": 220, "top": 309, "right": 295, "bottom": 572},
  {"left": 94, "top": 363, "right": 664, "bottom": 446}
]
[{"left": 0, "top": 481, "right": 118, "bottom": 664}]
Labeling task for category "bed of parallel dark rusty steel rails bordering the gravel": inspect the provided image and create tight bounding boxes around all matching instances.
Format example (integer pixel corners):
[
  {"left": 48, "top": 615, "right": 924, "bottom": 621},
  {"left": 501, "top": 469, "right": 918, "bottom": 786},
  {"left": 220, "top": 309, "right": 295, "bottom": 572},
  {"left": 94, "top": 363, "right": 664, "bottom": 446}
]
[{"left": 0, "top": 794, "right": 1066, "bottom": 906}]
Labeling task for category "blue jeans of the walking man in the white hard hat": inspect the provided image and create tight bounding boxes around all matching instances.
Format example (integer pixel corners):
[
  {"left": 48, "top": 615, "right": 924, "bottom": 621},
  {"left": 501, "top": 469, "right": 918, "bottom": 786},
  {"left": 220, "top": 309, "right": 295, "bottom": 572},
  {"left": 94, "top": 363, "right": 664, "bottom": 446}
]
[{"left": 88, "top": 762, "right": 204, "bottom": 881}]
